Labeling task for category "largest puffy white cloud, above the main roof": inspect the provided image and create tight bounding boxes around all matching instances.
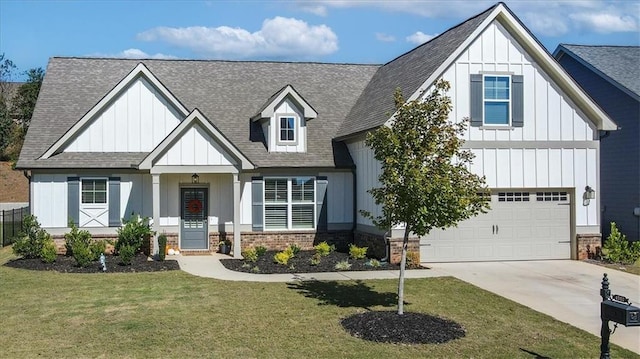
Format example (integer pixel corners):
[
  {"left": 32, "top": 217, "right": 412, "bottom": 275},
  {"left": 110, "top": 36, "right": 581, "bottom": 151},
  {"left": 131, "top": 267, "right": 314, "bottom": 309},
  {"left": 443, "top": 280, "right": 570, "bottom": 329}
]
[{"left": 137, "top": 16, "right": 338, "bottom": 59}]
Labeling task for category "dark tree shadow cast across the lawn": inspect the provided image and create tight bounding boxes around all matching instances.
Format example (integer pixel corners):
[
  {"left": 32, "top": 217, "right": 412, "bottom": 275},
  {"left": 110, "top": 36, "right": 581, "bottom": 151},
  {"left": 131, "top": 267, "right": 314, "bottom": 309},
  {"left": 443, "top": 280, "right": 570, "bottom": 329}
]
[{"left": 288, "top": 281, "right": 398, "bottom": 310}]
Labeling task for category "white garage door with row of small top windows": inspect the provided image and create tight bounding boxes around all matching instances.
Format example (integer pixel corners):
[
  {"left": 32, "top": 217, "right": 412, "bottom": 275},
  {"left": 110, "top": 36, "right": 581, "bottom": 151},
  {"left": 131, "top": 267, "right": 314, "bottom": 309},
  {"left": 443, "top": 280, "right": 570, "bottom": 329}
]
[{"left": 420, "top": 191, "right": 571, "bottom": 262}]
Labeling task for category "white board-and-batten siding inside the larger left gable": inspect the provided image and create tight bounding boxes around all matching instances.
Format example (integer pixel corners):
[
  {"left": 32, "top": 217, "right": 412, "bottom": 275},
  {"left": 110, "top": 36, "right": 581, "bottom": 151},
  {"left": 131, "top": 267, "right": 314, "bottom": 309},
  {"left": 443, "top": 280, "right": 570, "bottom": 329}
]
[{"left": 64, "top": 77, "right": 182, "bottom": 152}]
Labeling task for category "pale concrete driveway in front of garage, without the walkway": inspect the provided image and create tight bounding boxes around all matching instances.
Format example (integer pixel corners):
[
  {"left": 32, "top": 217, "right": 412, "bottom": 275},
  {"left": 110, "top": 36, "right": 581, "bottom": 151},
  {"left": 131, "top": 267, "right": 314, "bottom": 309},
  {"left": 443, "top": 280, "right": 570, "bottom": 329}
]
[{"left": 429, "top": 260, "right": 640, "bottom": 354}]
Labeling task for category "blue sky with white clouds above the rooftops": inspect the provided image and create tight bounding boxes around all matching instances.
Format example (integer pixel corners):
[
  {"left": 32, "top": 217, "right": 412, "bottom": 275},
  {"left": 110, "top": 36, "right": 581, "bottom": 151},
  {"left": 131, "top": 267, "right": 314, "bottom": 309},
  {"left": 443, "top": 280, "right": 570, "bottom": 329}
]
[{"left": 0, "top": 0, "right": 640, "bottom": 81}]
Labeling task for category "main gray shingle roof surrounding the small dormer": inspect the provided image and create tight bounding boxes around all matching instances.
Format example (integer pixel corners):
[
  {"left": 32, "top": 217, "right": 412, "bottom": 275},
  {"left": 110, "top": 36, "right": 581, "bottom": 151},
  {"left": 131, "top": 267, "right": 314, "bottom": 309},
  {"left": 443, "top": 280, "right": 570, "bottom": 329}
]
[{"left": 18, "top": 57, "right": 379, "bottom": 168}]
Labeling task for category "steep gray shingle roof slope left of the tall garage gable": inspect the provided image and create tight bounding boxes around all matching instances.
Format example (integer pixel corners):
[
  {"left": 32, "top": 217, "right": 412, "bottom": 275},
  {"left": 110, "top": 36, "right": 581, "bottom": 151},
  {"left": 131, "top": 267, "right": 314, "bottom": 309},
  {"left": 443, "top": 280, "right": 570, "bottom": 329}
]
[{"left": 338, "top": 4, "right": 498, "bottom": 137}]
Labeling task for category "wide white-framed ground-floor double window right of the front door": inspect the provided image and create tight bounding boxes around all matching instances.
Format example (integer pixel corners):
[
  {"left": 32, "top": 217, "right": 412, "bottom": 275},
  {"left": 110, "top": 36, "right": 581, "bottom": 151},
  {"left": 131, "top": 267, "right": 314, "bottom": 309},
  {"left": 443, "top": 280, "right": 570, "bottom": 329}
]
[{"left": 264, "top": 177, "right": 316, "bottom": 229}]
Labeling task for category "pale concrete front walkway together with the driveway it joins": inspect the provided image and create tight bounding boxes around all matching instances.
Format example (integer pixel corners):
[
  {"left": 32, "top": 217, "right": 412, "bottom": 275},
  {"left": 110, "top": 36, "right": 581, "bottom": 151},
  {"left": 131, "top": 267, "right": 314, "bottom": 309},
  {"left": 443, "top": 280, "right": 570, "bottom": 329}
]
[{"left": 175, "top": 253, "right": 640, "bottom": 354}]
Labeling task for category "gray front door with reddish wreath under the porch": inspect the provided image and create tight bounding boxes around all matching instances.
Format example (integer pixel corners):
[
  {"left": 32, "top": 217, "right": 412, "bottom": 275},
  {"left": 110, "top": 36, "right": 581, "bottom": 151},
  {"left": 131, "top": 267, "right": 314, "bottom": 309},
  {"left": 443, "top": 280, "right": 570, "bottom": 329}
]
[{"left": 180, "top": 188, "right": 209, "bottom": 249}]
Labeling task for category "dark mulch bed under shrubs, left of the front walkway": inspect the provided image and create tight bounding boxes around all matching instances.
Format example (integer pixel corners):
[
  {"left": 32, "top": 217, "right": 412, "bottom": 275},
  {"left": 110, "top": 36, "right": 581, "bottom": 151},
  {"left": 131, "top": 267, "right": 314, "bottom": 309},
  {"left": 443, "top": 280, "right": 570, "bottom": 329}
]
[{"left": 5, "top": 254, "right": 180, "bottom": 273}]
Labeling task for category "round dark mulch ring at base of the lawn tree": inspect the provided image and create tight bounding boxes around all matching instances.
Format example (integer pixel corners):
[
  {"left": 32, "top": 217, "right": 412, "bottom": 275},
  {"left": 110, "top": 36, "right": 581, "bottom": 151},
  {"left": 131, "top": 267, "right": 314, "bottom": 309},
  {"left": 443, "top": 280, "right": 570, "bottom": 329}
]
[{"left": 341, "top": 311, "right": 466, "bottom": 344}]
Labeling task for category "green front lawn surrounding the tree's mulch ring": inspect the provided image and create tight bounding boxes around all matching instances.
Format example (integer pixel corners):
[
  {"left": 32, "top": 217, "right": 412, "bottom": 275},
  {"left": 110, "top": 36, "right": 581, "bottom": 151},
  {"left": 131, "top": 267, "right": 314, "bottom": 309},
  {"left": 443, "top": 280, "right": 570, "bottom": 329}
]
[{"left": 0, "top": 248, "right": 640, "bottom": 358}]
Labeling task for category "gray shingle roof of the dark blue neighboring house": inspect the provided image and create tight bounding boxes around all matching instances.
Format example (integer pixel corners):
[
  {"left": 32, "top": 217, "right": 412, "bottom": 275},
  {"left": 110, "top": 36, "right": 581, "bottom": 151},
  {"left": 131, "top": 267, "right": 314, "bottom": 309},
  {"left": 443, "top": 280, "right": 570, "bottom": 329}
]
[{"left": 559, "top": 44, "right": 640, "bottom": 96}]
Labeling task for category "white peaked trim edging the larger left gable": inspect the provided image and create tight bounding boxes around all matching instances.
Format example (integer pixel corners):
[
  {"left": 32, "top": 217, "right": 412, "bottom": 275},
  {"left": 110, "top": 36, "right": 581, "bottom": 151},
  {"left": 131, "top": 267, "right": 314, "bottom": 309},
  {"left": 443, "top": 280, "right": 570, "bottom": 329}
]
[{"left": 41, "top": 62, "right": 189, "bottom": 159}]
